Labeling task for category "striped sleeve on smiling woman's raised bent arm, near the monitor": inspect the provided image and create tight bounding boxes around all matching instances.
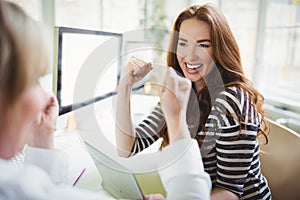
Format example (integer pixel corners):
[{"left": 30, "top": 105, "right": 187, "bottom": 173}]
[{"left": 131, "top": 103, "right": 165, "bottom": 156}]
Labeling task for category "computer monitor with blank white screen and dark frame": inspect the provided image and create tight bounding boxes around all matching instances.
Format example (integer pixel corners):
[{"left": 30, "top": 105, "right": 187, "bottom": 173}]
[{"left": 53, "top": 27, "right": 122, "bottom": 115}]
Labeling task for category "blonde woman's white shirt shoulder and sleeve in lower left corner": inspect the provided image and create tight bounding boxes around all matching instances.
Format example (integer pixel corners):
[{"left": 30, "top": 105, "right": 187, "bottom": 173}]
[{"left": 0, "top": 147, "right": 111, "bottom": 200}]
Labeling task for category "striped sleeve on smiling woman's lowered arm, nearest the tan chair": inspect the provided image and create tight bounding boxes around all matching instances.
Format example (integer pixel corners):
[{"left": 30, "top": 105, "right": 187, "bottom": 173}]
[{"left": 208, "top": 88, "right": 259, "bottom": 196}]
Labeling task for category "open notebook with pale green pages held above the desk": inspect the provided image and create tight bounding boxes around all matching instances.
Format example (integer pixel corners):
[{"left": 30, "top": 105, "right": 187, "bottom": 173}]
[{"left": 84, "top": 141, "right": 166, "bottom": 199}]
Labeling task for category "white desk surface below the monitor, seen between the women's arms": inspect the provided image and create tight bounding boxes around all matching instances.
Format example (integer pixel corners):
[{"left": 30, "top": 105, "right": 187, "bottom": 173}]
[{"left": 55, "top": 95, "right": 158, "bottom": 199}]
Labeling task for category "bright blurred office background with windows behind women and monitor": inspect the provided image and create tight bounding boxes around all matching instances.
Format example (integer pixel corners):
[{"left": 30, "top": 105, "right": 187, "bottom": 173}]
[{"left": 6, "top": 0, "right": 300, "bottom": 198}]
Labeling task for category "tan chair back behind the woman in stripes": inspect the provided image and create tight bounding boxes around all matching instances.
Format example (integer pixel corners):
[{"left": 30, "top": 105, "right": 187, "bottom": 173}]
[{"left": 260, "top": 120, "right": 300, "bottom": 200}]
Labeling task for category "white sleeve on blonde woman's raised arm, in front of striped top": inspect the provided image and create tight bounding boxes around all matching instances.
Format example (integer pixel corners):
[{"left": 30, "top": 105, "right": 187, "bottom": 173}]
[{"left": 159, "top": 139, "right": 211, "bottom": 200}]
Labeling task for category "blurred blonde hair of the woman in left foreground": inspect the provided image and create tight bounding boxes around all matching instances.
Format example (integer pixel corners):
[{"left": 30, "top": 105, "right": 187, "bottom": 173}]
[{"left": 0, "top": 1, "right": 50, "bottom": 108}]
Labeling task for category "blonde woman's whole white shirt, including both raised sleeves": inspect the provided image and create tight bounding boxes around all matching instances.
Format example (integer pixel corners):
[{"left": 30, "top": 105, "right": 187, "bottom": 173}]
[{"left": 0, "top": 139, "right": 211, "bottom": 200}]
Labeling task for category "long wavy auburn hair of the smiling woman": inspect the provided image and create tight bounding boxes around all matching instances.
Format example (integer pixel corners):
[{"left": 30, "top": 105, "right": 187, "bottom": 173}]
[{"left": 158, "top": 4, "right": 269, "bottom": 148}]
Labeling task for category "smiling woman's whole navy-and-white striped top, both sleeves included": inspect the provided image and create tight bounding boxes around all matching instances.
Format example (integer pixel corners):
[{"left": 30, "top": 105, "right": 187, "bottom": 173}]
[{"left": 132, "top": 87, "right": 271, "bottom": 199}]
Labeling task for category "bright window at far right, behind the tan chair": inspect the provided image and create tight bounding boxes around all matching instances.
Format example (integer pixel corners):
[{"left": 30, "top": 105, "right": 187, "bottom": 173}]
[{"left": 255, "top": 0, "right": 300, "bottom": 132}]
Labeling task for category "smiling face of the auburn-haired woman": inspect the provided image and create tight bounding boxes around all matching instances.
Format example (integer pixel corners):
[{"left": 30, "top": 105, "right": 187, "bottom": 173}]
[{"left": 176, "top": 18, "right": 215, "bottom": 84}]
